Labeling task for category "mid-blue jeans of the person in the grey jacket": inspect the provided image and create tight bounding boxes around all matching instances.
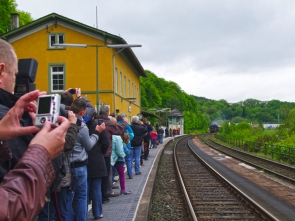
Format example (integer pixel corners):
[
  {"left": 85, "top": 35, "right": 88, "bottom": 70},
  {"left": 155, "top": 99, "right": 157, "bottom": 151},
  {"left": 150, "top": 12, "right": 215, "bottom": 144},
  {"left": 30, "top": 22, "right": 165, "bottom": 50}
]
[{"left": 71, "top": 166, "right": 88, "bottom": 221}]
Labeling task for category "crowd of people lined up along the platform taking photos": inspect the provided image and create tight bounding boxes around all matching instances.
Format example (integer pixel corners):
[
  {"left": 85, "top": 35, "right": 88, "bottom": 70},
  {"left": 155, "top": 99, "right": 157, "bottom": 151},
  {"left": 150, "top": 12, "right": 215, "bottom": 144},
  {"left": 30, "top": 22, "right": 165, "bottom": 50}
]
[{"left": 0, "top": 39, "right": 175, "bottom": 221}]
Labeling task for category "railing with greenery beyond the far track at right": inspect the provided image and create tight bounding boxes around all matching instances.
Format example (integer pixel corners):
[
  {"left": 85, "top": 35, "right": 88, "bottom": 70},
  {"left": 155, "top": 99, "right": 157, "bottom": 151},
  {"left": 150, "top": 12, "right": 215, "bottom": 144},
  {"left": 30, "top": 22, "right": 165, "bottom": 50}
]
[{"left": 215, "top": 134, "right": 295, "bottom": 165}]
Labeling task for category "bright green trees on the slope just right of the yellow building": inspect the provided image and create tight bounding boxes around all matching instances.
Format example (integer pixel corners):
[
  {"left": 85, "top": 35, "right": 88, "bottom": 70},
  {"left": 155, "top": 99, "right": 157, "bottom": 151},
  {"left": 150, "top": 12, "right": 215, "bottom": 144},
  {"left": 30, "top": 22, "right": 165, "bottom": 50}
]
[{"left": 140, "top": 70, "right": 209, "bottom": 134}]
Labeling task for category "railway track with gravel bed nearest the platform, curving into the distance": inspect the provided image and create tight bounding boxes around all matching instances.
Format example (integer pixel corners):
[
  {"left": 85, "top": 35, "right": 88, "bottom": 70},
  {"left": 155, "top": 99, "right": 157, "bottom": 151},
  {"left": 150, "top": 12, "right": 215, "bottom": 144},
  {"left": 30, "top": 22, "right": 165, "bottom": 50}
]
[{"left": 148, "top": 136, "right": 277, "bottom": 220}]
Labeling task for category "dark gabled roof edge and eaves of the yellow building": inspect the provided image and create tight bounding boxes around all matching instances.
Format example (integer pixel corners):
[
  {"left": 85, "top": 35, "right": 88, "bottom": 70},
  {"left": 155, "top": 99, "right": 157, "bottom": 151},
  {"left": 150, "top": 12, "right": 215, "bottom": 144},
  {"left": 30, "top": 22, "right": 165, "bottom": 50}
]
[{"left": 0, "top": 13, "right": 147, "bottom": 77}]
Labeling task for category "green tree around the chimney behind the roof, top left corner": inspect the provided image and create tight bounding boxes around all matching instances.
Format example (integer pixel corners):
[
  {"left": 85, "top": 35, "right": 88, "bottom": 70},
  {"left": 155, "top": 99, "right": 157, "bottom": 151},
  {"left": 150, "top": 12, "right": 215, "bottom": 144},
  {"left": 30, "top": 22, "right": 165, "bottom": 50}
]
[{"left": 0, "top": 0, "right": 33, "bottom": 35}]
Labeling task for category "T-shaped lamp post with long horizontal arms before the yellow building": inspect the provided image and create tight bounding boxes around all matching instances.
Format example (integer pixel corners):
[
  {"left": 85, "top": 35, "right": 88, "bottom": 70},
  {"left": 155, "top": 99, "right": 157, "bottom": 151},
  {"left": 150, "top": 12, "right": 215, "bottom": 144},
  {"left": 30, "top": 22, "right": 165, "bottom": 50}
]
[{"left": 53, "top": 43, "right": 141, "bottom": 112}]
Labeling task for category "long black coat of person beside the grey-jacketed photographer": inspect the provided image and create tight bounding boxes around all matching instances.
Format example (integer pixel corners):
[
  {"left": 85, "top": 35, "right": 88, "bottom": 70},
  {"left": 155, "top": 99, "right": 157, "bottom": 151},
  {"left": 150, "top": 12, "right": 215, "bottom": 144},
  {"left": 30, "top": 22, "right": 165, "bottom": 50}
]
[{"left": 87, "top": 120, "right": 109, "bottom": 178}]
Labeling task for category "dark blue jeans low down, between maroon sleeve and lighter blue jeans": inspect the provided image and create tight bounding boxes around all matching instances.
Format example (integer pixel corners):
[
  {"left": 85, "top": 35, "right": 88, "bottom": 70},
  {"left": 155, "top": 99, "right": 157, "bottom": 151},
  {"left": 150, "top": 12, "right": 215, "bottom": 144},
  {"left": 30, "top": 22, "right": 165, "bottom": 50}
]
[{"left": 57, "top": 187, "right": 74, "bottom": 221}]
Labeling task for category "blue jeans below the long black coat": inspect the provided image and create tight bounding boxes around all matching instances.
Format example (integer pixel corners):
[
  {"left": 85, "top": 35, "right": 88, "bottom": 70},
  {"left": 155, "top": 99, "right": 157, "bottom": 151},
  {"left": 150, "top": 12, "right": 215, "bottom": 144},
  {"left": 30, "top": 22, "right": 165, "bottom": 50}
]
[{"left": 88, "top": 177, "right": 102, "bottom": 218}]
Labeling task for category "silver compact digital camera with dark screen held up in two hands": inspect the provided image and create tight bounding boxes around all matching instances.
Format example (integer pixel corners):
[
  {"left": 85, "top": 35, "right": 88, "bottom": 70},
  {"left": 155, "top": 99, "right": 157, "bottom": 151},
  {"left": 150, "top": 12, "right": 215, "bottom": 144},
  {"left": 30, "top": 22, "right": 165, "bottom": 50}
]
[{"left": 35, "top": 94, "right": 60, "bottom": 127}]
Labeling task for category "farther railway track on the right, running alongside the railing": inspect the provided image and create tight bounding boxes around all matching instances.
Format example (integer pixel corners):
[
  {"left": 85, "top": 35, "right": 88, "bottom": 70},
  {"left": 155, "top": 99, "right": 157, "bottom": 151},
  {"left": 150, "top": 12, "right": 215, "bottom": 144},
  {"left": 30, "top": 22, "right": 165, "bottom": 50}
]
[{"left": 198, "top": 135, "right": 295, "bottom": 184}]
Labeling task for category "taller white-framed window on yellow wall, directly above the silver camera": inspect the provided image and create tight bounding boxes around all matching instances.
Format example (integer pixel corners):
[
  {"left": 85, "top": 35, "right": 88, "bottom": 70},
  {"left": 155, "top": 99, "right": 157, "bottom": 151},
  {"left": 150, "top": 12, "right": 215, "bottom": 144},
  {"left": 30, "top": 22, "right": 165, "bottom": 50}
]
[{"left": 50, "top": 65, "right": 65, "bottom": 92}]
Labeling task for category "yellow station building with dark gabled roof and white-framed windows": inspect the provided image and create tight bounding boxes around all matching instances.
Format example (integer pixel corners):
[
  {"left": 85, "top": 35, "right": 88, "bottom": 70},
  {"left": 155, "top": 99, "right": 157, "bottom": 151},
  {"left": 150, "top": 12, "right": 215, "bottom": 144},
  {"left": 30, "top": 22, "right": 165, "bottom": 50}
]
[{"left": 1, "top": 13, "right": 147, "bottom": 118}]
